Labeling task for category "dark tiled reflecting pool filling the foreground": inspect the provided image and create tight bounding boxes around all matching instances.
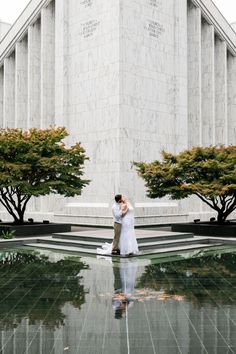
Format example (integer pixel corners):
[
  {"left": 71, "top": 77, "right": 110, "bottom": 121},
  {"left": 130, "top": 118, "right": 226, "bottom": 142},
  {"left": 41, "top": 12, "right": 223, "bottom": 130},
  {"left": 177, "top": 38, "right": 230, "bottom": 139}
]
[{"left": 0, "top": 246, "right": 236, "bottom": 354}]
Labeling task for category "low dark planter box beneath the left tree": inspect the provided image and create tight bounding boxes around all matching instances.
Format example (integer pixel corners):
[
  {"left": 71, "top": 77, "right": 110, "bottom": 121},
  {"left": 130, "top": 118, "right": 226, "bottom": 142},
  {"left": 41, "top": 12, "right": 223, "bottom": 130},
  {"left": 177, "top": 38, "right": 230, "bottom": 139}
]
[{"left": 0, "top": 222, "right": 71, "bottom": 237}]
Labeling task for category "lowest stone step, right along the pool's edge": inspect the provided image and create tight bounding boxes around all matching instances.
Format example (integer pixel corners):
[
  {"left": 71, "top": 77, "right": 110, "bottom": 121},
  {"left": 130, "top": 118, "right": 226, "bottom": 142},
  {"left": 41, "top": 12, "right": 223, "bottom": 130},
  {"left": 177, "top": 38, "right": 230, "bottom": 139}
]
[{"left": 24, "top": 242, "right": 221, "bottom": 257}]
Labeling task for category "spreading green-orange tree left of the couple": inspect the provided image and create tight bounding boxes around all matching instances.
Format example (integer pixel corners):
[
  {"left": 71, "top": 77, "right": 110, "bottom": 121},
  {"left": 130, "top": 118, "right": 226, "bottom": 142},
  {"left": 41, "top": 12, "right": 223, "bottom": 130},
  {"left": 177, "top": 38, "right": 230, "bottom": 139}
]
[{"left": 0, "top": 128, "right": 89, "bottom": 224}]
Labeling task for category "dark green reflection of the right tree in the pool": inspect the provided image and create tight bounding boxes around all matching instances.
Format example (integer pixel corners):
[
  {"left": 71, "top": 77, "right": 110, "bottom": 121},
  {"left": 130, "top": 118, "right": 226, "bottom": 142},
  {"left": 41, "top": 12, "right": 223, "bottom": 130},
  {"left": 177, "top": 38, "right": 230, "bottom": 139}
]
[{"left": 137, "top": 253, "right": 236, "bottom": 307}]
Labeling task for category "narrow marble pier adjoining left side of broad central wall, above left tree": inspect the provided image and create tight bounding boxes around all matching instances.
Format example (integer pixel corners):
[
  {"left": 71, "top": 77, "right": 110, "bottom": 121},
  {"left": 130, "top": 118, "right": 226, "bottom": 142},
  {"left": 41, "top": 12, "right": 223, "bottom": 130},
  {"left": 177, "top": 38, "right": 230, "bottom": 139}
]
[{"left": 55, "top": 0, "right": 68, "bottom": 126}]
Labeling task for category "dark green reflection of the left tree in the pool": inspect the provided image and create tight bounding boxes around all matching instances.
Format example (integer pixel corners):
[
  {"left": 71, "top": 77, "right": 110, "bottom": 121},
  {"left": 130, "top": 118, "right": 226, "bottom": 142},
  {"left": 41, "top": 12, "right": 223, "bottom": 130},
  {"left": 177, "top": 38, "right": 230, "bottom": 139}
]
[{"left": 0, "top": 251, "right": 86, "bottom": 330}]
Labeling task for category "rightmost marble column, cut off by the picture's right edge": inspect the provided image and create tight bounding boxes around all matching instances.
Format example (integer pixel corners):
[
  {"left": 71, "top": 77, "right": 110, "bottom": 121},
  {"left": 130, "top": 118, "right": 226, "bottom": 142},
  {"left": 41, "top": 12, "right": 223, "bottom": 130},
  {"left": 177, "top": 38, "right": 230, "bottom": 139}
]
[{"left": 226, "top": 53, "right": 236, "bottom": 145}]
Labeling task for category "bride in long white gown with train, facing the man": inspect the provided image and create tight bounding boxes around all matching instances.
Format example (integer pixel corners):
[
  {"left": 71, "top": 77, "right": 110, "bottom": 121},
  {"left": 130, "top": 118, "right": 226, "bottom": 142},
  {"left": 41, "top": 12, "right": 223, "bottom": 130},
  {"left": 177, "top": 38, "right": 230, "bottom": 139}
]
[{"left": 97, "top": 195, "right": 138, "bottom": 256}]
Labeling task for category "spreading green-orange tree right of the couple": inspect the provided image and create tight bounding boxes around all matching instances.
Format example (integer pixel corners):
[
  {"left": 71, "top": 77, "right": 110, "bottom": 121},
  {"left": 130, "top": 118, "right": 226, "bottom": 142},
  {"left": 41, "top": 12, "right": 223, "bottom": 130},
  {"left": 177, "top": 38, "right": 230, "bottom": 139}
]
[{"left": 134, "top": 146, "right": 236, "bottom": 224}]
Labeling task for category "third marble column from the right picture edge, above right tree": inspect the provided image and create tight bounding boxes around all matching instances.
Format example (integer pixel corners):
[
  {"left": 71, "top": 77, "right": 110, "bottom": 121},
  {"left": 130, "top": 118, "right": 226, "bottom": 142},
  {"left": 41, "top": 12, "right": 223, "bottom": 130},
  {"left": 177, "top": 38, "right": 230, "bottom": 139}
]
[{"left": 201, "top": 19, "right": 215, "bottom": 146}]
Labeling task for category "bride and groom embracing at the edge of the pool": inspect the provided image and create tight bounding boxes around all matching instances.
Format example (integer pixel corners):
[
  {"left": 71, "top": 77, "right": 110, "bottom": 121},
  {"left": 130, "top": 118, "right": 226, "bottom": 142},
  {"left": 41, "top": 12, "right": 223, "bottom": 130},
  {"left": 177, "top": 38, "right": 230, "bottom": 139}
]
[{"left": 97, "top": 194, "right": 138, "bottom": 256}]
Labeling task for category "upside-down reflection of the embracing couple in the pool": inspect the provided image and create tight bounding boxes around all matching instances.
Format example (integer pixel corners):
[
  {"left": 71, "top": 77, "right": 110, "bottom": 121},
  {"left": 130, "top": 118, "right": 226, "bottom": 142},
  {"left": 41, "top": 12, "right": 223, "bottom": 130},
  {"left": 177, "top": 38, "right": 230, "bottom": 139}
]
[{"left": 112, "top": 258, "right": 149, "bottom": 319}]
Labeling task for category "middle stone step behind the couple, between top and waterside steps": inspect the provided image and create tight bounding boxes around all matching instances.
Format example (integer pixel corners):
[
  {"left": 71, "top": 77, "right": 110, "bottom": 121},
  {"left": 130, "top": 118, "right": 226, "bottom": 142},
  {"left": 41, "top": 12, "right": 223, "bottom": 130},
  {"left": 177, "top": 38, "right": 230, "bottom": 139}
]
[{"left": 32, "top": 236, "right": 207, "bottom": 250}]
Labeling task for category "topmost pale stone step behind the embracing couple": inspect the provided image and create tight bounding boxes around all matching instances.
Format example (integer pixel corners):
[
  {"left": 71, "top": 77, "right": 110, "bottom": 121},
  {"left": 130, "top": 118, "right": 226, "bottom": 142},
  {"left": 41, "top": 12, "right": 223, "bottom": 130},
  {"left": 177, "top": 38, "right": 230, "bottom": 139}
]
[{"left": 52, "top": 230, "right": 194, "bottom": 244}]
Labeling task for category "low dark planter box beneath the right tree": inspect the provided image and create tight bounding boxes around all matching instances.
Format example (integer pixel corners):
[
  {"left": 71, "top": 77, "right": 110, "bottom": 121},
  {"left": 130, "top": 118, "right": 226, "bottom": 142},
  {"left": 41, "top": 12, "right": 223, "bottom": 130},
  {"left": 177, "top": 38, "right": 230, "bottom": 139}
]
[{"left": 171, "top": 222, "right": 236, "bottom": 237}]
